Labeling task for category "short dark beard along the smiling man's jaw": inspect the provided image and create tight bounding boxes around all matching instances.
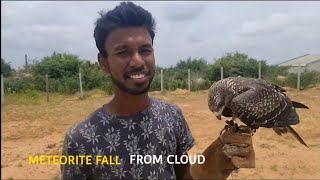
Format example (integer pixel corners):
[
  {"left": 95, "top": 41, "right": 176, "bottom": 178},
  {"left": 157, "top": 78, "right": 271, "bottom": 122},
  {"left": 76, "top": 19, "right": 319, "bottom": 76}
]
[{"left": 110, "top": 73, "right": 154, "bottom": 95}]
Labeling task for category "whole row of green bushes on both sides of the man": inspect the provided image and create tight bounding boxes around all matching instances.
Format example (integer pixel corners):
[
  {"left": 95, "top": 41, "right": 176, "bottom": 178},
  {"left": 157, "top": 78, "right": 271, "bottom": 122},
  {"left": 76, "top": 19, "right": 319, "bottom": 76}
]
[{"left": 1, "top": 52, "right": 320, "bottom": 94}]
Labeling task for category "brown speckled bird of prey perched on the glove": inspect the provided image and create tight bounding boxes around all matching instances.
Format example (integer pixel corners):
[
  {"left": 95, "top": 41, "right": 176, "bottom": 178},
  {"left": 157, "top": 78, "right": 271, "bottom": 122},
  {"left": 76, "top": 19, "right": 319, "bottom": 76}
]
[{"left": 208, "top": 77, "right": 309, "bottom": 148}]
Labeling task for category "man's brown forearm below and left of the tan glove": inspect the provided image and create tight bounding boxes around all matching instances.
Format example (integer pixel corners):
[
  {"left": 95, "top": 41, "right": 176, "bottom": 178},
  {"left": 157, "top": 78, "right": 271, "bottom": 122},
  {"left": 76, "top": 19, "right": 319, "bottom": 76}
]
[{"left": 189, "top": 138, "right": 235, "bottom": 179}]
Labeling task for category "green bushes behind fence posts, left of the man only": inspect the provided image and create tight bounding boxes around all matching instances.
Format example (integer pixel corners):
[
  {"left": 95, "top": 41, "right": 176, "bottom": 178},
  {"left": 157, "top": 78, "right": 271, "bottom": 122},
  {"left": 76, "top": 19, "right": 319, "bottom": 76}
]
[{"left": 5, "top": 52, "right": 112, "bottom": 94}]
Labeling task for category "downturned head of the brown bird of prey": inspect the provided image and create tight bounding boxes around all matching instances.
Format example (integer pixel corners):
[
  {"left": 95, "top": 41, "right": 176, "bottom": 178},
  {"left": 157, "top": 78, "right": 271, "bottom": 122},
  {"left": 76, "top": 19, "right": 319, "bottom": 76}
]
[{"left": 208, "top": 94, "right": 226, "bottom": 120}]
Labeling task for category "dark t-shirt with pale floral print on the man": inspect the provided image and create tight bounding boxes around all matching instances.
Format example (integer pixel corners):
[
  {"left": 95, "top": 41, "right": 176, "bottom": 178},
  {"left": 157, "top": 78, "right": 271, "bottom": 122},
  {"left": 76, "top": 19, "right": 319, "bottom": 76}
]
[{"left": 61, "top": 97, "right": 194, "bottom": 179}]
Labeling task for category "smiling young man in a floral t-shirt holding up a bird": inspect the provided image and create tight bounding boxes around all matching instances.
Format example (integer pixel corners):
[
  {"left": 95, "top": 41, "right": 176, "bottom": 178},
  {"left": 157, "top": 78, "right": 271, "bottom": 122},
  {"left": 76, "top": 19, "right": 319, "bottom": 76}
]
[{"left": 61, "top": 2, "right": 251, "bottom": 179}]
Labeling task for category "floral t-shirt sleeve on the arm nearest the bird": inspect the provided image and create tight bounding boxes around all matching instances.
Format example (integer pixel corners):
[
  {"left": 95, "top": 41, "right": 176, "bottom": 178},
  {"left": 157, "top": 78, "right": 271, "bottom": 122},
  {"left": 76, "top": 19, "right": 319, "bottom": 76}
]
[{"left": 176, "top": 108, "right": 195, "bottom": 155}]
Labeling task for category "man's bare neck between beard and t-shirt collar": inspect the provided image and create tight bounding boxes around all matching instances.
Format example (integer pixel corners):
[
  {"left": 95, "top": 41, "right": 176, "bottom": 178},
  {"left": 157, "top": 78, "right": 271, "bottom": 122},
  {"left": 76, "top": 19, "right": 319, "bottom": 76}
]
[{"left": 106, "top": 92, "right": 150, "bottom": 116}]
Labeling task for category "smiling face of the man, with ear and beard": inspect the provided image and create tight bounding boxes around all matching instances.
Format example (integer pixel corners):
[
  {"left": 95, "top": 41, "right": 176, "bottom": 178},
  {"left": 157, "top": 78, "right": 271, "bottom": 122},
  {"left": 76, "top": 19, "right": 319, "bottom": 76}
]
[{"left": 98, "top": 27, "right": 155, "bottom": 95}]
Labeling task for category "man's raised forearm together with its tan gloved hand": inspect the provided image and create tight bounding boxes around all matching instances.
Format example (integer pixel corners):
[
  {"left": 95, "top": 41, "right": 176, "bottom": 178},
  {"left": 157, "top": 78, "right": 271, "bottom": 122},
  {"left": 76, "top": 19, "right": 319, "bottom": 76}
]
[{"left": 190, "top": 126, "right": 255, "bottom": 179}]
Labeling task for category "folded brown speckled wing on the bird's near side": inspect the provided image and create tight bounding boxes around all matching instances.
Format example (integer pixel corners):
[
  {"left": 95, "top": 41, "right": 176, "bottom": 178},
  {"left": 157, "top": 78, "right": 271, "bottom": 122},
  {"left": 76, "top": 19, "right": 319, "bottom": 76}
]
[{"left": 230, "top": 86, "right": 290, "bottom": 127}]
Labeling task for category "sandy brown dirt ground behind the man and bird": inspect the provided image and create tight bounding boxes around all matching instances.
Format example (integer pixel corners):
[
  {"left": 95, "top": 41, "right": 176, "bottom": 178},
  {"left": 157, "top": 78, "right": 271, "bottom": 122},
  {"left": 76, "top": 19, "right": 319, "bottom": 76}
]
[{"left": 1, "top": 89, "right": 320, "bottom": 179}]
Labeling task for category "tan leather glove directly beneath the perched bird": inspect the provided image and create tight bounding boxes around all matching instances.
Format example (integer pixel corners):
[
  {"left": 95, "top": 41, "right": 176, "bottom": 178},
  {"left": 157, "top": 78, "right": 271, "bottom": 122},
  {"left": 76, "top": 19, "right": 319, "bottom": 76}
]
[{"left": 219, "top": 128, "right": 255, "bottom": 169}]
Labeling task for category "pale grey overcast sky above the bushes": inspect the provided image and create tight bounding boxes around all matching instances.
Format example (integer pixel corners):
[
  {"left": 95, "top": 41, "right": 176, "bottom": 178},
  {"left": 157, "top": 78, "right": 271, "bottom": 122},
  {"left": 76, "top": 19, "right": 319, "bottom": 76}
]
[{"left": 1, "top": 1, "right": 320, "bottom": 68}]
